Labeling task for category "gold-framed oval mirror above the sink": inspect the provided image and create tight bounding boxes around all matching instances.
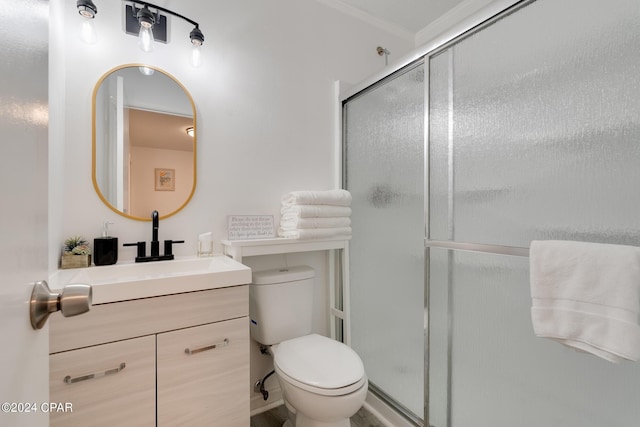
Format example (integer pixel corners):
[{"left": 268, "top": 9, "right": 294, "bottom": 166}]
[{"left": 92, "top": 64, "right": 197, "bottom": 224}]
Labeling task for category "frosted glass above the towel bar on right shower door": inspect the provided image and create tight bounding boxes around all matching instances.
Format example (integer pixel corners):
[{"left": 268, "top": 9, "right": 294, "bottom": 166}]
[{"left": 430, "top": 0, "right": 640, "bottom": 247}]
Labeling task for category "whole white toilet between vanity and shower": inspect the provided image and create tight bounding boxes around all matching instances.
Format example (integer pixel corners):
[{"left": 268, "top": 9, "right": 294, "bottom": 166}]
[{"left": 249, "top": 266, "right": 368, "bottom": 427}]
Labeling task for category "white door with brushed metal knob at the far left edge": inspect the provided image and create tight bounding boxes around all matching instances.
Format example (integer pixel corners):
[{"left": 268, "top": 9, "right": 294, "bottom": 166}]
[{"left": 0, "top": 0, "right": 49, "bottom": 427}]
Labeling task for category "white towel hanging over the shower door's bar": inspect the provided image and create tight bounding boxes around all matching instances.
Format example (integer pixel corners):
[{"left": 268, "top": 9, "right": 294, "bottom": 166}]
[{"left": 529, "top": 241, "right": 640, "bottom": 363}]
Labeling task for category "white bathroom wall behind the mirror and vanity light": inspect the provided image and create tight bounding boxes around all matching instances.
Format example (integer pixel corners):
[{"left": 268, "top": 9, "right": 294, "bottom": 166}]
[{"left": 50, "top": 0, "right": 412, "bottom": 416}]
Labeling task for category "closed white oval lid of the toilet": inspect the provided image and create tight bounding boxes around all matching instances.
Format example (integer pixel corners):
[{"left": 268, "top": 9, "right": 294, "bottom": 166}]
[{"left": 274, "top": 334, "right": 364, "bottom": 389}]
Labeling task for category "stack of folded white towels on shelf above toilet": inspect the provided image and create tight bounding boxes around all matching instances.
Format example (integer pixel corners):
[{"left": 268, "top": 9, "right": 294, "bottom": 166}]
[{"left": 278, "top": 190, "right": 351, "bottom": 239}]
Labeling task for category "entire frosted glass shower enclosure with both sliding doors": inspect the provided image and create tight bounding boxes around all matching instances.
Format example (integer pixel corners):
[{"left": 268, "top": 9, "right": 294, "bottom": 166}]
[{"left": 343, "top": 0, "right": 640, "bottom": 427}]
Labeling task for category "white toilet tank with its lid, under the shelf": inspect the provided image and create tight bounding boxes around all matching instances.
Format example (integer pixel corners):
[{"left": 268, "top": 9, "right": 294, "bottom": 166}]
[{"left": 249, "top": 265, "right": 315, "bottom": 345}]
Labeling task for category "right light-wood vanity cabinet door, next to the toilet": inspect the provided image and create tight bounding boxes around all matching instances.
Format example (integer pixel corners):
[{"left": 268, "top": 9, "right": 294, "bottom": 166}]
[{"left": 157, "top": 317, "right": 250, "bottom": 427}]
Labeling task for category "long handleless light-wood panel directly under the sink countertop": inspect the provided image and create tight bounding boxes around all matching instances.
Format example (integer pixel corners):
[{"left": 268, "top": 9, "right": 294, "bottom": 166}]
[{"left": 49, "top": 285, "right": 249, "bottom": 353}]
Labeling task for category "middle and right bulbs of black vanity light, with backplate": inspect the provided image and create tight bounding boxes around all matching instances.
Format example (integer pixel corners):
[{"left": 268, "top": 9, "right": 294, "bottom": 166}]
[{"left": 122, "top": 0, "right": 204, "bottom": 67}]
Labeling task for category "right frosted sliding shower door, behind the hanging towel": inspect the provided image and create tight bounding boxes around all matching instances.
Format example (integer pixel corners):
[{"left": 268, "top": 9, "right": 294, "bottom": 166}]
[{"left": 428, "top": 0, "right": 640, "bottom": 427}]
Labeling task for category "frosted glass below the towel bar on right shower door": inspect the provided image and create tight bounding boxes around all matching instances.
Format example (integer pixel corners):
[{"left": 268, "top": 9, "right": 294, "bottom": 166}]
[{"left": 429, "top": 249, "right": 640, "bottom": 427}]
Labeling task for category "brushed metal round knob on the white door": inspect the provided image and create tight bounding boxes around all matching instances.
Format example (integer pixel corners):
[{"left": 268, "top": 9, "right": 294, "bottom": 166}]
[{"left": 29, "top": 280, "right": 92, "bottom": 329}]
